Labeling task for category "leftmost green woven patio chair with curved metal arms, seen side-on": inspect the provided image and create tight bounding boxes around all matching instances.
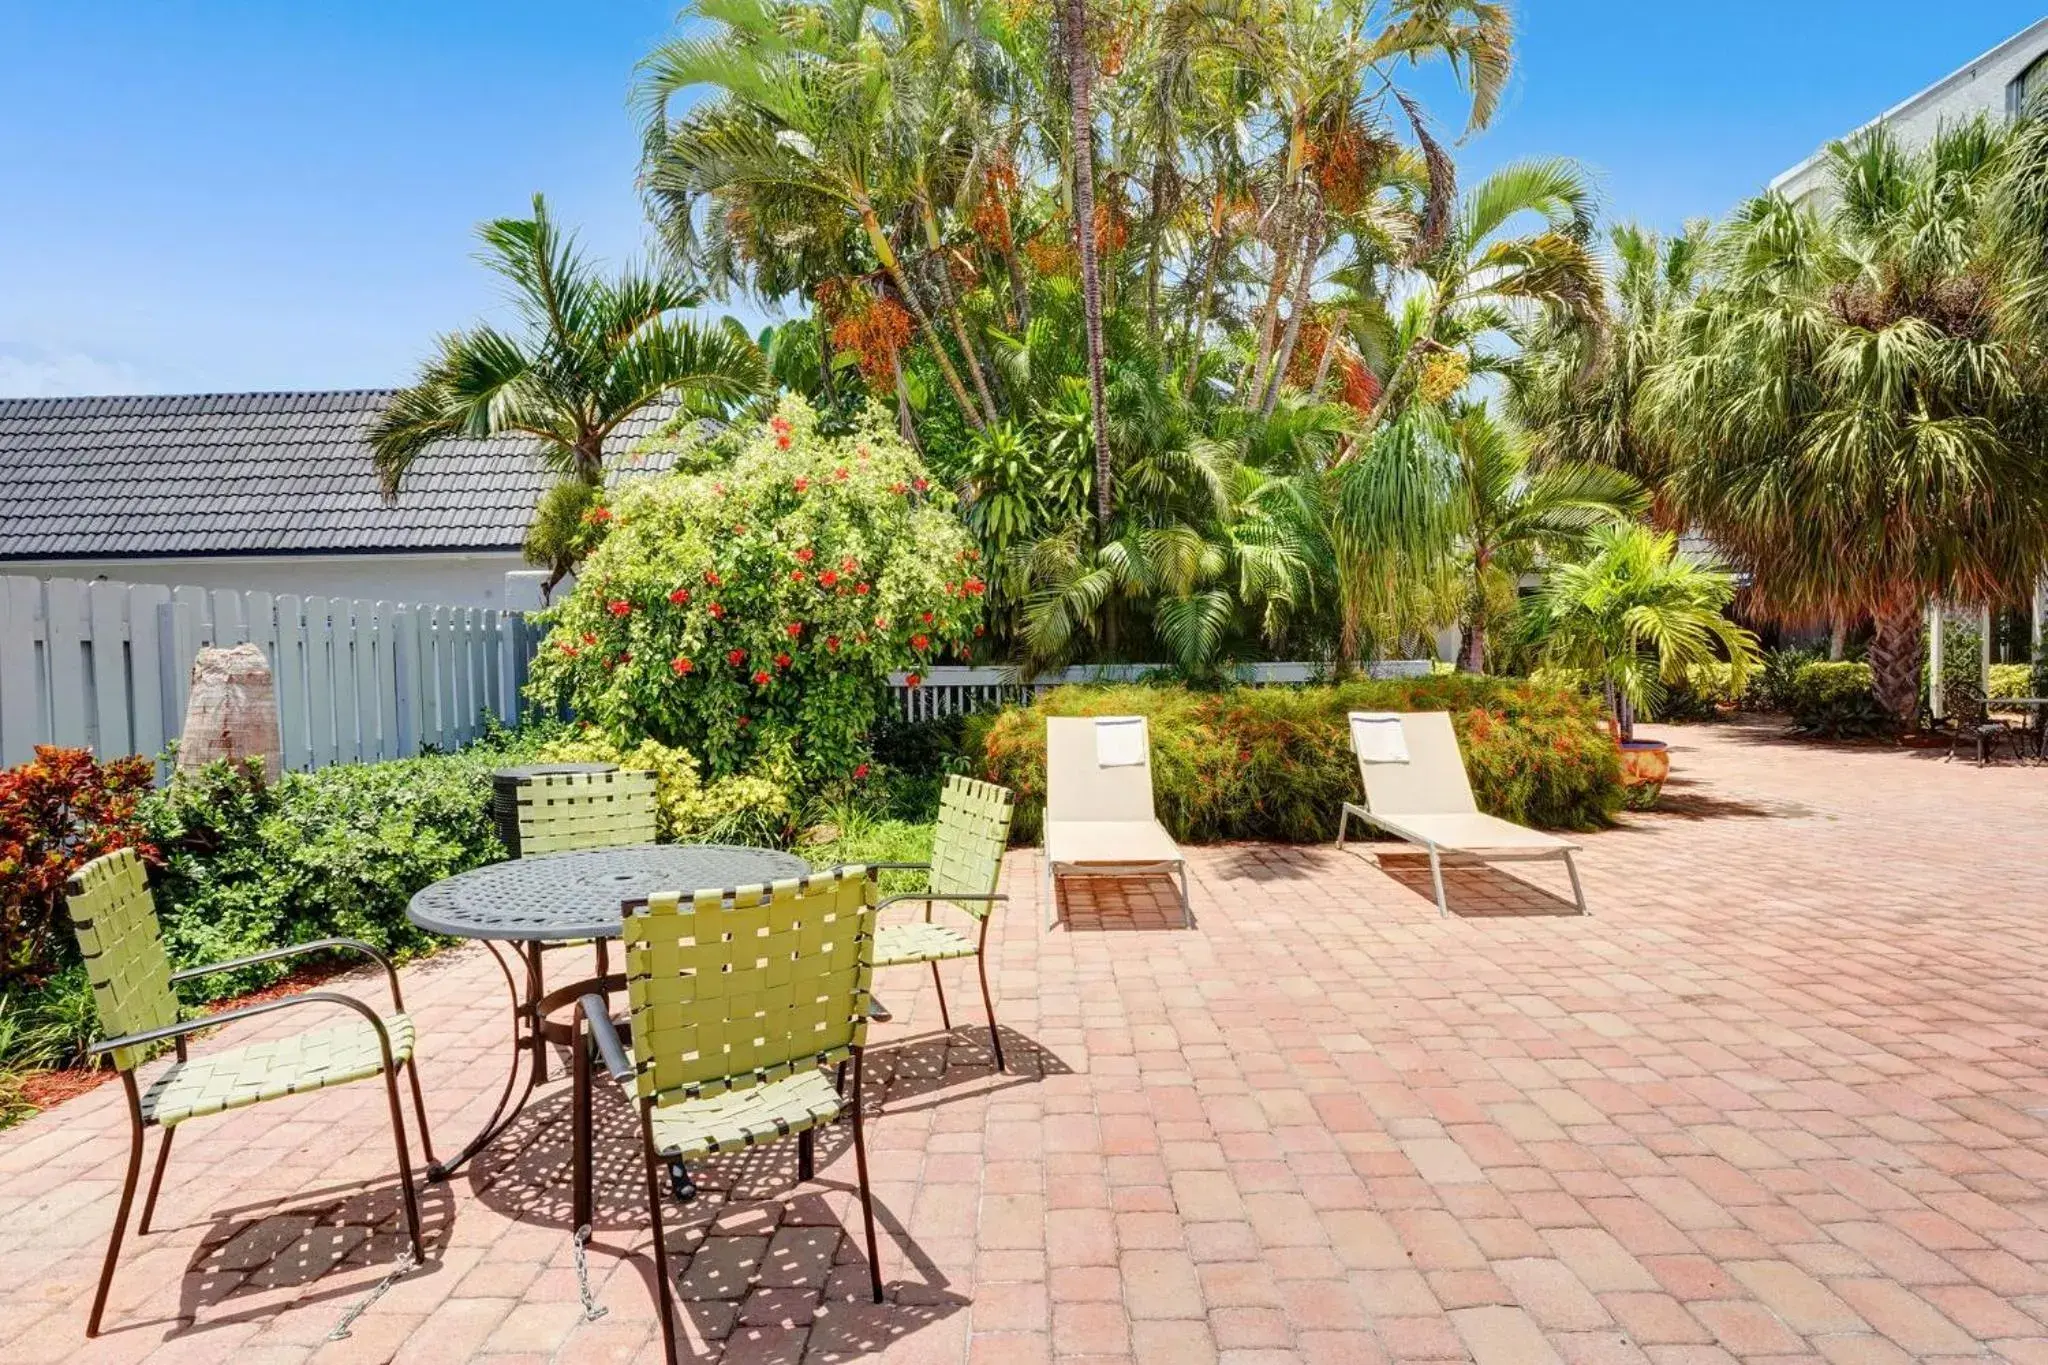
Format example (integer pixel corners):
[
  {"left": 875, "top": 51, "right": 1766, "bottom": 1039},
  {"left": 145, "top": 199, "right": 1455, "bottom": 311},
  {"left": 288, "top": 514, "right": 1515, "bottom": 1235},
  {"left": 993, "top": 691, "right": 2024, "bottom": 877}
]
[{"left": 66, "top": 849, "right": 434, "bottom": 1336}]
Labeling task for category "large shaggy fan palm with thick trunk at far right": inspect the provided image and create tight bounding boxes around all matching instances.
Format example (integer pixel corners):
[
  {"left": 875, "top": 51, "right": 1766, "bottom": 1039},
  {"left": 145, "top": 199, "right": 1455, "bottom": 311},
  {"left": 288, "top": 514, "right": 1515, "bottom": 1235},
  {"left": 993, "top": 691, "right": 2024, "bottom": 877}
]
[{"left": 1642, "top": 121, "right": 2048, "bottom": 729}]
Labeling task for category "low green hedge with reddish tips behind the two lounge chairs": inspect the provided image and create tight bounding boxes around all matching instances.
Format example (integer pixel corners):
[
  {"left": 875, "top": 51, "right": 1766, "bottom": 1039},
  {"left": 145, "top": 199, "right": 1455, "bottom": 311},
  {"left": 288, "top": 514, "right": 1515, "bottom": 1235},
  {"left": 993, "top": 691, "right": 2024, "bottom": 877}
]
[{"left": 977, "top": 675, "right": 1622, "bottom": 843}]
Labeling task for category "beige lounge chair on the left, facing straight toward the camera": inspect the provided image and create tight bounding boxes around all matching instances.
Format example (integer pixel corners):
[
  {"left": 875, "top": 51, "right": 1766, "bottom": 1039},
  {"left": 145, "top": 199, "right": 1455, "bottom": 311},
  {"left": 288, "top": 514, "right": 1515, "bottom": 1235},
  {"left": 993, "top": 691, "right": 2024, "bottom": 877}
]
[{"left": 1044, "top": 716, "right": 1194, "bottom": 929}]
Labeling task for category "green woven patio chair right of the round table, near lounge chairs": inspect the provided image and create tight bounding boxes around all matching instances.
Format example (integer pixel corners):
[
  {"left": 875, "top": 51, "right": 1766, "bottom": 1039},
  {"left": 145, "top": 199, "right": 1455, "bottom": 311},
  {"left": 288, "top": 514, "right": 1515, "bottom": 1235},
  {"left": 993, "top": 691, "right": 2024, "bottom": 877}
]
[{"left": 874, "top": 776, "right": 1016, "bottom": 1070}]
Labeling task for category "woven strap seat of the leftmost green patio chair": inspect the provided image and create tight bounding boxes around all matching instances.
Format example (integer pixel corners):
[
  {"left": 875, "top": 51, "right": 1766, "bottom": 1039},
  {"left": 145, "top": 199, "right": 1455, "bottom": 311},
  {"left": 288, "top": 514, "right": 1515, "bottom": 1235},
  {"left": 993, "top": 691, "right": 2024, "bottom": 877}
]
[{"left": 141, "top": 1015, "right": 414, "bottom": 1128}]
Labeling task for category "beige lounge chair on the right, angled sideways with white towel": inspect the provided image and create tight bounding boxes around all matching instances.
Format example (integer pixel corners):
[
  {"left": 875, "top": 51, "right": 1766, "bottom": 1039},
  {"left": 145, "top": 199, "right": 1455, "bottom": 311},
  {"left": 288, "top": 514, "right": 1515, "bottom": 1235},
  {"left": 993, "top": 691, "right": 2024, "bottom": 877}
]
[{"left": 1337, "top": 710, "right": 1589, "bottom": 915}]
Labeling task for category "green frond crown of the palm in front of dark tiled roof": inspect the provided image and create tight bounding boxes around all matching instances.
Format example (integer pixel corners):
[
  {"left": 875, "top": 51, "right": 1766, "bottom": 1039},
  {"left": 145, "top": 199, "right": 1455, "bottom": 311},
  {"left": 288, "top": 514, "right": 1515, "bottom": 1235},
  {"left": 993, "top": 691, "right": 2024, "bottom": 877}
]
[{"left": 371, "top": 194, "right": 768, "bottom": 507}]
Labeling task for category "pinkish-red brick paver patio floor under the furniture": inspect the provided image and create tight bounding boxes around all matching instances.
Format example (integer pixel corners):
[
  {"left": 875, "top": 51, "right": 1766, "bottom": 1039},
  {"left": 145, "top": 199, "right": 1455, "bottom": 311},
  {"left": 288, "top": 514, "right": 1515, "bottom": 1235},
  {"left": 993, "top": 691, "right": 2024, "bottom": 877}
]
[{"left": 0, "top": 726, "right": 2048, "bottom": 1365}]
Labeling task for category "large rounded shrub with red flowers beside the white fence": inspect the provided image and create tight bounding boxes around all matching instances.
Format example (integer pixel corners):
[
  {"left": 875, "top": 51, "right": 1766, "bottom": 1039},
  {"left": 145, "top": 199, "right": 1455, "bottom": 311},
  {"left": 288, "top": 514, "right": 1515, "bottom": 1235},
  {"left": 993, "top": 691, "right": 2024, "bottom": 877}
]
[{"left": 535, "top": 399, "right": 985, "bottom": 780}]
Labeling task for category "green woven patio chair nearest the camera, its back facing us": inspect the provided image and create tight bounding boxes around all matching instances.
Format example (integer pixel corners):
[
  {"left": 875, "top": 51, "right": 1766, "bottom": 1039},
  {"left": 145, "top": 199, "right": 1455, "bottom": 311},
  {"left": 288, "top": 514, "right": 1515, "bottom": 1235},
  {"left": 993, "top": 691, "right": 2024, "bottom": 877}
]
[{"left": 571, "top": 868, "right": 883, "bottom": 1361}]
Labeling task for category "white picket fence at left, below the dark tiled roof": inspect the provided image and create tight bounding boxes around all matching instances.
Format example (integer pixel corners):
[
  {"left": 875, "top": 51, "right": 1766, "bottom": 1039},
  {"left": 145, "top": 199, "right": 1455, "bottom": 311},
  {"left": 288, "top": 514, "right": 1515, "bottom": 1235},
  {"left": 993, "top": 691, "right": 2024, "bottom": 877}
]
[{"left": 0, "top": 577, "right": 532, "bottom": 769}]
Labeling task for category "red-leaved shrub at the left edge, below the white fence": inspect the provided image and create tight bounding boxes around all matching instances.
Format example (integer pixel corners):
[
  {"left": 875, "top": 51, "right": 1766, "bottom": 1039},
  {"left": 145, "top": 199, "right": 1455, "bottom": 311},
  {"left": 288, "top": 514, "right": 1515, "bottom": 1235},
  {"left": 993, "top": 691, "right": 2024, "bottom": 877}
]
[{"left": 0, "top": 745, "right": 156, "bottom": 984}]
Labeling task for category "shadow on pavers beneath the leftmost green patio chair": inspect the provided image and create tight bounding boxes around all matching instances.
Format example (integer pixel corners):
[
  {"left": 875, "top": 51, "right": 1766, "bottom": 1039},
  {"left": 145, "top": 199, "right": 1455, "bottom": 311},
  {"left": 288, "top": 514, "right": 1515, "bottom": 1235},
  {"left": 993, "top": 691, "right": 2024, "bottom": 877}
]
[{"left": 164, "top": 1177, "right": 455, "bottom": 1338}]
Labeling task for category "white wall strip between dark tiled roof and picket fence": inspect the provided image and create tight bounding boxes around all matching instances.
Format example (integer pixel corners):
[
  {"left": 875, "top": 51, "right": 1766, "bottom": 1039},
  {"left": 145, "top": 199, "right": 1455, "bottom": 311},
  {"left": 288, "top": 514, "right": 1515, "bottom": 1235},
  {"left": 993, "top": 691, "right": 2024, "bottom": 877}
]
[{"left": 0, "top": 551, "right": 528, "bottom": 608}]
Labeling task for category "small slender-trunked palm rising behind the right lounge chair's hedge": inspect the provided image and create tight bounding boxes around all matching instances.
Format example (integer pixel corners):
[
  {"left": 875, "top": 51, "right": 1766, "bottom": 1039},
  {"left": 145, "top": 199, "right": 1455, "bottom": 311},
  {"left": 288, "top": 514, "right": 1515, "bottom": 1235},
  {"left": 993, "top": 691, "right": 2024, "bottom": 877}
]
[{"left": 1450, "top": 405, "right": 1647, "bottom": 673}]
